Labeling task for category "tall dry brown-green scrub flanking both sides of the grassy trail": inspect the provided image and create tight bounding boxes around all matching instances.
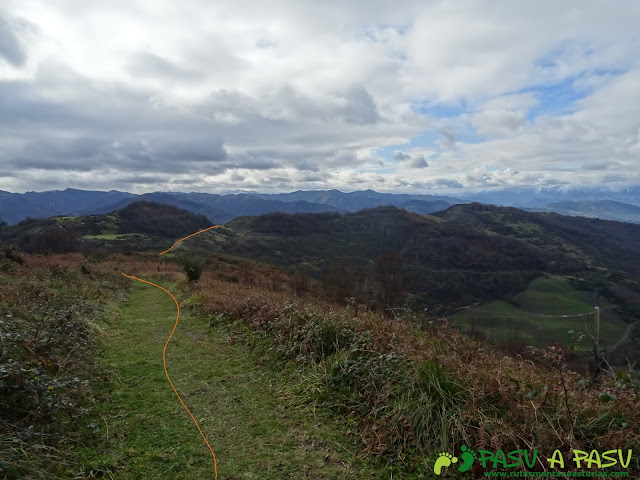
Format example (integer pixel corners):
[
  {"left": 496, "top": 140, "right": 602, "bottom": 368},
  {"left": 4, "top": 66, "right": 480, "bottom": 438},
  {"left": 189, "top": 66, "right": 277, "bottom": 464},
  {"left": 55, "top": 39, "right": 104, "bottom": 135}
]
[{"left": 0, "top": 249, "right": 640, "bottom": 478}]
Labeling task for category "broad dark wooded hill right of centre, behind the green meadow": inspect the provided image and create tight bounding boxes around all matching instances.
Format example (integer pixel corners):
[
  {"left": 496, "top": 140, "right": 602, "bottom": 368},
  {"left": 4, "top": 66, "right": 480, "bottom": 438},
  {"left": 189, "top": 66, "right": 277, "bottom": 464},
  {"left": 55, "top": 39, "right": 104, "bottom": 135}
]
[{"left": 189, "top": 204, "right": 640, "bottom": 310}]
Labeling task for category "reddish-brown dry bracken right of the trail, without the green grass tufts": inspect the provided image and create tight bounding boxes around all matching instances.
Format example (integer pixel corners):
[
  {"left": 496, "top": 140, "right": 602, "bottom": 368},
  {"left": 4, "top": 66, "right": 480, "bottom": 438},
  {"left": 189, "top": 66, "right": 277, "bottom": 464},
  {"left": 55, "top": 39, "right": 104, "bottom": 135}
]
[{"left": 182, "top": 253, "right": 640, "bottom": 474}]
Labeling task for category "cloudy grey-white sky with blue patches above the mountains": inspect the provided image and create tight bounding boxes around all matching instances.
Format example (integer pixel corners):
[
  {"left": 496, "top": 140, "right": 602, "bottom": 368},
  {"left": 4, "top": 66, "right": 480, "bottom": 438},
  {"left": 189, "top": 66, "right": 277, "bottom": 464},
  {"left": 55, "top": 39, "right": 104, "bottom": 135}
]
[{"left": 0, "top": 0, "right": 640, "bottom": 193}]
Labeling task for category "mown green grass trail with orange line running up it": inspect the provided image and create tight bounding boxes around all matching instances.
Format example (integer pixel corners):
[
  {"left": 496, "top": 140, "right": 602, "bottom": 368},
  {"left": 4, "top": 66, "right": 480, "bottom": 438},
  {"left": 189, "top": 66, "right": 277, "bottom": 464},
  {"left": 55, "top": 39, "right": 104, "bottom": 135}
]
[{"left": 84, "top": 282, "right": 377, "bottom": 480}]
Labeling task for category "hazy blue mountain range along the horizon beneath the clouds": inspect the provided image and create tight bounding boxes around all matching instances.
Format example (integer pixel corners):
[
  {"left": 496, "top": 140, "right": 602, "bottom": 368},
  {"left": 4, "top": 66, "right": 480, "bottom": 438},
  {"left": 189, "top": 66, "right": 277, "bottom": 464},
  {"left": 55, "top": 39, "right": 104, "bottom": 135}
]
[{"left": 0, "top": 186, "right": 640, "bottom": 225}]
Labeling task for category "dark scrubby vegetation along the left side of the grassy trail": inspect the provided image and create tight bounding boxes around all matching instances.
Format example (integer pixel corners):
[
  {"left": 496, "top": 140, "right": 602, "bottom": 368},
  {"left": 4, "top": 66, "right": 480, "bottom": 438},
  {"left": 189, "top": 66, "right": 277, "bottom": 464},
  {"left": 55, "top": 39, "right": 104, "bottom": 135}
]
[{"left": 0, "top": 247, "right": 126, "bottom": 478}]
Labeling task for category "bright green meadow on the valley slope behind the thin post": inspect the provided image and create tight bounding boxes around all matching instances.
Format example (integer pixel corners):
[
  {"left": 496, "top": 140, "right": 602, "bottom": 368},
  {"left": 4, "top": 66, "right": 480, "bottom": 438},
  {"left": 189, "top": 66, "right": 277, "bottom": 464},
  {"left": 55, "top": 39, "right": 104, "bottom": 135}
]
[{"left": 451, "top": 277, "right": 628, "bottom": 350}]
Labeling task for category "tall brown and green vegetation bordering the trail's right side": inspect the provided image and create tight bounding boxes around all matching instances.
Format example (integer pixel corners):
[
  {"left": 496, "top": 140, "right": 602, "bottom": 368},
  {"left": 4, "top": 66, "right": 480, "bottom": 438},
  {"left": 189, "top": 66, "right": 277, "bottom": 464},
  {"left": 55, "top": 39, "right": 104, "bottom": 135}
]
[{"left": 190, "top": 256, "right": 640, "bottom": 471}]
